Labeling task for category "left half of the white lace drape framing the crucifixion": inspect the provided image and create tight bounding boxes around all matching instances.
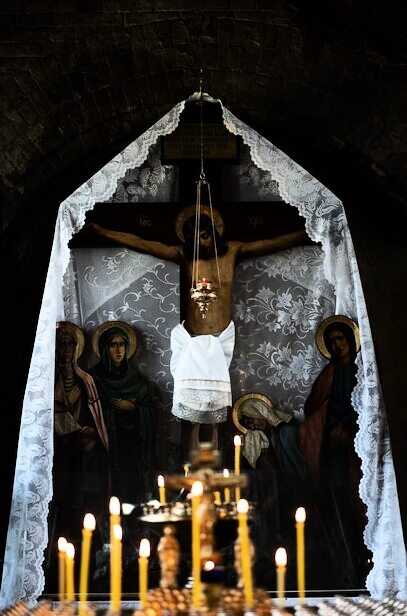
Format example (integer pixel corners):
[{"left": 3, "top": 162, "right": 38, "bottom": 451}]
[{"left": 0, "top": 102, "right": 185, "bottom": 607}]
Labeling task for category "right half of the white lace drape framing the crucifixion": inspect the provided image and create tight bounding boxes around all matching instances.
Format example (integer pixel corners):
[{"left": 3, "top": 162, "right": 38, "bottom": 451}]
[{"left": 223, "top": 107, "right": 407, "bottom": 597}]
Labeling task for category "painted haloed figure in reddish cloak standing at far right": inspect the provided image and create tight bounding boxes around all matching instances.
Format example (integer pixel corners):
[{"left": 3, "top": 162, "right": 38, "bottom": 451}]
[{"left": 298, "top": 315, "right": 371, "bottom": 588}]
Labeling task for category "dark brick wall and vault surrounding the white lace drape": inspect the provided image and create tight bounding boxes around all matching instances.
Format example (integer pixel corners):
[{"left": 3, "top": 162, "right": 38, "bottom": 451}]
[{"left": 0, "top": 0, "right": 407, "bottom": 604}]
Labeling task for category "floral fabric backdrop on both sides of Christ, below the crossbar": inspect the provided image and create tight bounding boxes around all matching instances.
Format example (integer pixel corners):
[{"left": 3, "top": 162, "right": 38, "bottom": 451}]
[{"left": 64, "top": 246, "right": 335, "bottom": 460}]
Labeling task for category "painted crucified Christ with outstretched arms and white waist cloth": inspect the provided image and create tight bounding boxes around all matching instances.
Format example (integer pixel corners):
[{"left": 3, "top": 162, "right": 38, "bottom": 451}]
[{"left": 88, "top": 213, "right": 308, "bottom": 450}]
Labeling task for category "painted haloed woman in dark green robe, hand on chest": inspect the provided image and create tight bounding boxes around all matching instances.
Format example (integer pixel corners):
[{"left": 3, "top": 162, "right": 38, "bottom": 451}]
[{"left": 91, "top": 321, "right": 155, "bottom": 502}]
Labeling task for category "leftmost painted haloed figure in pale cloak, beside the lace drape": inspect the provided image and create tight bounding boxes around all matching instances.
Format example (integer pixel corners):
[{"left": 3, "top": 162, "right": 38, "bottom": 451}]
[{"left": 45, "top": 321, "right": 109, "bottom": 592}]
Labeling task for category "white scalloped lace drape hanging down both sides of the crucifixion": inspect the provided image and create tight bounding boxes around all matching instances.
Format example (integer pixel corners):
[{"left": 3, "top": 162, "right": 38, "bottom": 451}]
[{"left": 0, "top": 97, "right": 407, "bottom": 607}]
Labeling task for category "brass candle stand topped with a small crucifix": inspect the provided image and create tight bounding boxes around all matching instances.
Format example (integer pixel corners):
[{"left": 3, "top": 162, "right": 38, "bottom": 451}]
[{"left": 137, "top": 443, "right": 271, "bottom": 616}]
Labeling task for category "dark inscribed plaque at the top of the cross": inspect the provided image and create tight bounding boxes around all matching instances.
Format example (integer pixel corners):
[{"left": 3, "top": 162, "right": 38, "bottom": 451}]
[{"left": 163, "top": 124, "right": 238, "bottom": 162}]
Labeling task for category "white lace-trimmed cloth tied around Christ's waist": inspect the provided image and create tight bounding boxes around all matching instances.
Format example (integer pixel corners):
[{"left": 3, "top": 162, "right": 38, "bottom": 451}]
[{"left": 170, "top": 321, "right": 235, "bottom": 424}]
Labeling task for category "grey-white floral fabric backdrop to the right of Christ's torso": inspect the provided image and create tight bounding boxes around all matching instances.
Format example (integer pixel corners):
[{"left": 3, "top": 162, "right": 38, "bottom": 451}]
[{"left": 231, "top": 246, "right": 335, "bottom": 414}]
